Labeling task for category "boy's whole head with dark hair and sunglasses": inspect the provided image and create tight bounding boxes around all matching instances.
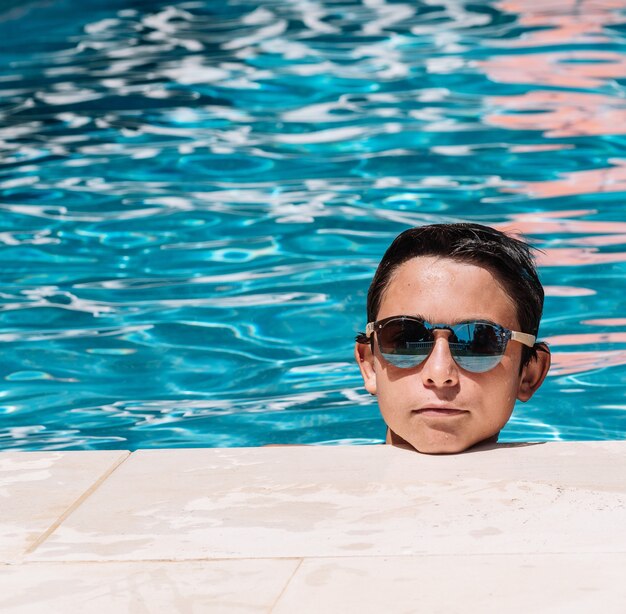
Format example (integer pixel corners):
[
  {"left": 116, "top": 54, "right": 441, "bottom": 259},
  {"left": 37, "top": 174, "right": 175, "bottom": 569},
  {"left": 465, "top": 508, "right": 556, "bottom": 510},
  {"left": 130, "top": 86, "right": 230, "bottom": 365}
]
[{"left": 355, "top": 224, "right": 550, "bottom": 453}]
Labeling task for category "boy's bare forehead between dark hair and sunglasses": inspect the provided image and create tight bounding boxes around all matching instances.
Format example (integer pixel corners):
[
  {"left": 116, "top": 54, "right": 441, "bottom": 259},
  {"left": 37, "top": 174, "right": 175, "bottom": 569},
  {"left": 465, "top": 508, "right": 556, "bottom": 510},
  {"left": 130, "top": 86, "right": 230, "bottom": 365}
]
[{"left": 376, "top": 256, "right": 518, "bottom": 328}]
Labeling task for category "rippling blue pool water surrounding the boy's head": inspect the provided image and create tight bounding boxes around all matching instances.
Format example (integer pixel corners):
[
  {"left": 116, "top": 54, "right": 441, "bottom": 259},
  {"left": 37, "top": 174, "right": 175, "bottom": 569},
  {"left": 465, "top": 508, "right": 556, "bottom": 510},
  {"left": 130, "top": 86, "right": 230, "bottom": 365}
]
[{"left": 0, "top": 0, "right": 626, "bottom": 450}]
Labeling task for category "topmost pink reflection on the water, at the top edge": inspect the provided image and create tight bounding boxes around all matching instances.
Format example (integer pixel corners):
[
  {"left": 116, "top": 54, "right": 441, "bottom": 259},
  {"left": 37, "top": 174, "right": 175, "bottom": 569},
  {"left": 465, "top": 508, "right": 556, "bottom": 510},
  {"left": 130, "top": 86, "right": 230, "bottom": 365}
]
[{"left": 496, "top": 0, "right": 624, "bottom": 47}]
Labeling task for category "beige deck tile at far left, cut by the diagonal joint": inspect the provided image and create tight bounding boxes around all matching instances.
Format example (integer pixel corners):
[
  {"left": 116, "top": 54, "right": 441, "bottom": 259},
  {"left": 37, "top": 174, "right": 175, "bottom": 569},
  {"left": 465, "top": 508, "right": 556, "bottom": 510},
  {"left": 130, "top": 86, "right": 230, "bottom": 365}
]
[{"left": 0, "top": 451, "right": 129, "bottom": 563}]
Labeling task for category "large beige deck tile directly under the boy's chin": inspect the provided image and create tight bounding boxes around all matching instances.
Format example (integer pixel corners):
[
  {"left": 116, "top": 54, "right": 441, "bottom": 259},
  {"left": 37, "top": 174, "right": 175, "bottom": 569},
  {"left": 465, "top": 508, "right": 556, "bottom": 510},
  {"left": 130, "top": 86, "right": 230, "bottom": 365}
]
[{"left": 27, "top": 444, "right": 626, "bottom": 561}]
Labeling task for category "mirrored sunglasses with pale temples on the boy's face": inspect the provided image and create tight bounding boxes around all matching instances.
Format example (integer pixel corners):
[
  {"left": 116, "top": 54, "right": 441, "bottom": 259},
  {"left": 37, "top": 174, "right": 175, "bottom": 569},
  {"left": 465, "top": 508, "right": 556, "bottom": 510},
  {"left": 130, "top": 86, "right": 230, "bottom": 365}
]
[{"left": 365, "top": 316, "right": 536, "bottom": 373}]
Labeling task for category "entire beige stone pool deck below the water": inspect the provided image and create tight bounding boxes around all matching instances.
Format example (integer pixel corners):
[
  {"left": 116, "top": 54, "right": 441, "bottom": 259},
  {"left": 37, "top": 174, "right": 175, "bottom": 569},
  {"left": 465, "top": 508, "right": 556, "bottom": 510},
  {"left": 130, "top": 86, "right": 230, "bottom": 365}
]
[{"left": 0, "top": 442, "right": 626, "bottom": 614}]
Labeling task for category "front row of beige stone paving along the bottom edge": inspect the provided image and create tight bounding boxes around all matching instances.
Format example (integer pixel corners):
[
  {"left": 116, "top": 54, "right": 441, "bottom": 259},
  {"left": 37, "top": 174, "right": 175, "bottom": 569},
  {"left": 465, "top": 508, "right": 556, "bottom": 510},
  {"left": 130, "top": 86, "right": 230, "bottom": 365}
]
[{"left": 0, "top": 553, "right": 626, "bottom": 614}]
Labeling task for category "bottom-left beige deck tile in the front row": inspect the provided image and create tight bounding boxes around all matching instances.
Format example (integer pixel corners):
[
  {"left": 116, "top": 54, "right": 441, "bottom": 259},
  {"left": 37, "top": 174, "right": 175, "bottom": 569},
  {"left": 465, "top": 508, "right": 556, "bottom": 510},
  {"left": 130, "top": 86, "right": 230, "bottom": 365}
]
[{"left": 0, "top": 559, "right": 300, "bottom": 614}]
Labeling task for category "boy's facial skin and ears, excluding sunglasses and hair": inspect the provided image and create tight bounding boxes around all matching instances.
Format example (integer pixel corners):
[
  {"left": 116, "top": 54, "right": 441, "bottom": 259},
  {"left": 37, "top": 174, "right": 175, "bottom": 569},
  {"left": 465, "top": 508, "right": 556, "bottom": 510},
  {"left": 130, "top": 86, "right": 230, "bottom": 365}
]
[{"left": 356, "top": 256, "right": 549, "bottom": 453}]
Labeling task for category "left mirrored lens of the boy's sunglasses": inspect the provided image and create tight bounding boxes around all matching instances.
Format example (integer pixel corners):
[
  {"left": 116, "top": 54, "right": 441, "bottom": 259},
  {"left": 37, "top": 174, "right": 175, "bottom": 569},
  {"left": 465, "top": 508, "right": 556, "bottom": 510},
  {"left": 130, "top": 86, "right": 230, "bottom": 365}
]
[{"left": 377, "top": 318, "right": 433, "bottom": 369}]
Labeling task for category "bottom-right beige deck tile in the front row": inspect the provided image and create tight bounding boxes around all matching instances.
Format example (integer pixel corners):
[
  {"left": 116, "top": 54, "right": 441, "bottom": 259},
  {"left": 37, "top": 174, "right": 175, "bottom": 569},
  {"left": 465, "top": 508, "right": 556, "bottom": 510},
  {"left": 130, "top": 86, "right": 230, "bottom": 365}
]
[{"left": 272, "top": 553, "right": 626, "bottom": 614}]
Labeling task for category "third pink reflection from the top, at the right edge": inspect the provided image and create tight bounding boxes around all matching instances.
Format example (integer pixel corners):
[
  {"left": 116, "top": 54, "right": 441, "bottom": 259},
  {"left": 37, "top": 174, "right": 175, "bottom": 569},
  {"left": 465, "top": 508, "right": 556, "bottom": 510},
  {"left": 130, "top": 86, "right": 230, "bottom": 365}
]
[{"left": 484, "top": 90, "right": 626, "bottom": 138}]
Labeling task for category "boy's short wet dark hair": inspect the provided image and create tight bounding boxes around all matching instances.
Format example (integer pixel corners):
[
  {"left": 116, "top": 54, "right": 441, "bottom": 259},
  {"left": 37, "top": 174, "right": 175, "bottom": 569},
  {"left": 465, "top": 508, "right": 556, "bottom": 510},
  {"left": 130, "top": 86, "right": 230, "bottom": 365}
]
[{"left": 356, "top": 223, "right": 544, "bottom": 368}]
